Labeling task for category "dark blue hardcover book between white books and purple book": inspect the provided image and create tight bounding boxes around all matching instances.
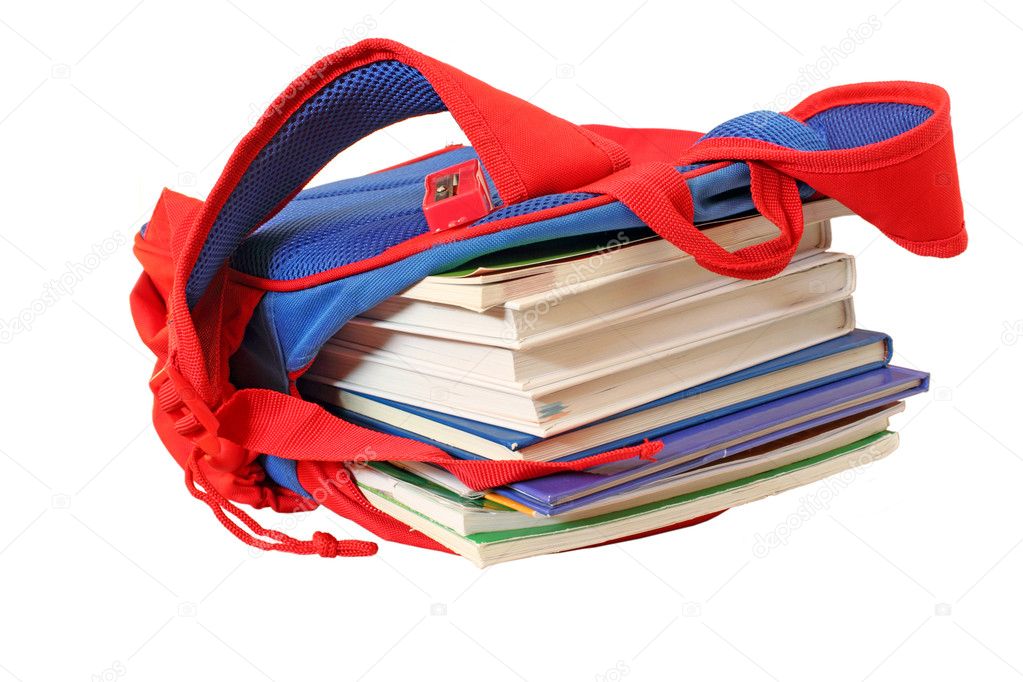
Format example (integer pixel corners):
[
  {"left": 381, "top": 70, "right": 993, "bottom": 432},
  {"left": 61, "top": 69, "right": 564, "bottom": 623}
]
[{"left": 306, "top": 329, "right": 892, "bottom": 461}]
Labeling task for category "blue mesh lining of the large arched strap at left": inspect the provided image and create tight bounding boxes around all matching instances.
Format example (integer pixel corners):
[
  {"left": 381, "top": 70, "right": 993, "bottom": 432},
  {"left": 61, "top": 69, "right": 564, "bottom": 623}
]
[{"left": 185, "top": 61, "right": 445, "bottom": 306}]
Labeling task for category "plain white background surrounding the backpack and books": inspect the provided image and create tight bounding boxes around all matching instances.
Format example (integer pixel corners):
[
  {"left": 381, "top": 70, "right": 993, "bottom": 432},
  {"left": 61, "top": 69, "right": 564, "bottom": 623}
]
[{"left": 0, "top": 0, "right": 1023, "bottom": 682}]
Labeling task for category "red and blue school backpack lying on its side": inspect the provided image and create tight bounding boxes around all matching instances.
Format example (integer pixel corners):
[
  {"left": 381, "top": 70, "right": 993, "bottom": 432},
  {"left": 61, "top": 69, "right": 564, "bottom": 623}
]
[{"left": 131, "top": 40, "right": 967, "bottom": 556}]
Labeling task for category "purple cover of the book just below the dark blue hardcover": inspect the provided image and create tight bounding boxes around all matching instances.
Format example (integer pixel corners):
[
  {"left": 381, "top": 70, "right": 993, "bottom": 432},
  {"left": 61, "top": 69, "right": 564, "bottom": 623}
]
[{"left": 499, "top": 367, "right": 929, "bottom": 514}]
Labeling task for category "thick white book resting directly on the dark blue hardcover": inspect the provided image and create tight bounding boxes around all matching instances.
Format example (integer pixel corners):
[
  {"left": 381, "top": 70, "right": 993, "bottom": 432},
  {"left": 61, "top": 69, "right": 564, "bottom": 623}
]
[{"left": 329, "top": 253, "right": 855, "bottom": 390}]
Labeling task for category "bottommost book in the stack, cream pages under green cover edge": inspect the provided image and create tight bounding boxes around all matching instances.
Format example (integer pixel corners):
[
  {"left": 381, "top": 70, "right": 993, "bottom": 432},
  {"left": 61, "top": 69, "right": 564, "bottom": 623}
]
[{"left": 362, "top": 431, "right": 898, "bottom": 566}]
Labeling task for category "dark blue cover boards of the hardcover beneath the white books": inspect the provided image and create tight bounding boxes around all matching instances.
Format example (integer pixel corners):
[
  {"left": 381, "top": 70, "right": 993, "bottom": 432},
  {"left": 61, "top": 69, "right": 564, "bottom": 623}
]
[{"left": 333, "top": 329, "right": 892, "bottom": 461}]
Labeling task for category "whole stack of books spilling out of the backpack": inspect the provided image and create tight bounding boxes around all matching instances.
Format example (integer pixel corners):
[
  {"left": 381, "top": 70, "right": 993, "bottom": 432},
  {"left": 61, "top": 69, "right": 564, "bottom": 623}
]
[{"left": 300, "top": 199, "right": 928, "bottom": 565}]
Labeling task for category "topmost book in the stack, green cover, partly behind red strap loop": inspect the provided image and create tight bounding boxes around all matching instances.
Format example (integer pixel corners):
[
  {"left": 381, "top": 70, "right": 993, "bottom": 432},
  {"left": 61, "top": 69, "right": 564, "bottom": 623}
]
[{"left": 390, "top": 199, "right": 850, "bottom": 318}]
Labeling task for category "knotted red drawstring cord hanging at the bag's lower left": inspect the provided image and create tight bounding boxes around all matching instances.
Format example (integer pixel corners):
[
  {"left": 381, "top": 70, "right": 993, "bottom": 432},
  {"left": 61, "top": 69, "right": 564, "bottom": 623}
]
[{"left": 185, "top": 453, "right": 376, "bottom": 558}]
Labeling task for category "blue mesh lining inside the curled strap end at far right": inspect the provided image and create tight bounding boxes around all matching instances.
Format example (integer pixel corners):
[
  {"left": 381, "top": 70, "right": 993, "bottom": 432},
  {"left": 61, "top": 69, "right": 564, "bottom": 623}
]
[{"left": 806, "top": 102, "right": 934, "bottom": 149}]
